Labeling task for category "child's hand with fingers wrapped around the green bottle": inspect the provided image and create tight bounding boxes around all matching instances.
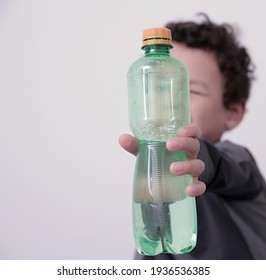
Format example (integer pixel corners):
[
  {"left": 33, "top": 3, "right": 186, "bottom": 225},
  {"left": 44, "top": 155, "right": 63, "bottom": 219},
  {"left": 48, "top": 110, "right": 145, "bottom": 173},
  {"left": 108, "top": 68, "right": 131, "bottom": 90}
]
[{"left": 119, "top": 125, "right": 206, "bottom": 196}]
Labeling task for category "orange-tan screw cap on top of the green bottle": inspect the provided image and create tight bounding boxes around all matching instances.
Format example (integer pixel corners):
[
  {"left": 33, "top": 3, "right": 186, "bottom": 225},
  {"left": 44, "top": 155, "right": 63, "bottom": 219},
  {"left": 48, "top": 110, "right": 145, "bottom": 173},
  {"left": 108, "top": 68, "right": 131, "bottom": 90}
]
[{"left": 142, "top": 28, "right": 172, "bottom": 47}]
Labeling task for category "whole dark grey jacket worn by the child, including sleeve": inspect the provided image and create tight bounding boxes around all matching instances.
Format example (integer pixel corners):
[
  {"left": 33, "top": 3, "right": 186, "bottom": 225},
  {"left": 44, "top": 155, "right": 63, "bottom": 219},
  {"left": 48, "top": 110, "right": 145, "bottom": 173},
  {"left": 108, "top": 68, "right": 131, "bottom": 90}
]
[{"left": 136, "top": 140, "right": 266, "bottom": 260}]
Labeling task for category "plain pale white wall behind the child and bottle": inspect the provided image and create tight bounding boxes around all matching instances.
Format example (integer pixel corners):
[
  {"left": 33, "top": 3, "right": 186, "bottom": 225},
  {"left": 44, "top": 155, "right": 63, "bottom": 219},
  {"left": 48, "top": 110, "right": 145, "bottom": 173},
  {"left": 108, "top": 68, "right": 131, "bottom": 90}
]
[{"left": 0, "top": 0, "right": 266, "bottom": 259}]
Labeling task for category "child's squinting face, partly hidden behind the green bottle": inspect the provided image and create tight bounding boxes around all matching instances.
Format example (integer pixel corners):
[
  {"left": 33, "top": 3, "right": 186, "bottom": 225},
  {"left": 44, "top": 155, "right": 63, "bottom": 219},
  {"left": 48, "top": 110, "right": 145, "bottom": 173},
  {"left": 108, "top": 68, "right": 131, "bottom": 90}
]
[{"left": 171, "top": 43, "right": 237, "bottom": 143}]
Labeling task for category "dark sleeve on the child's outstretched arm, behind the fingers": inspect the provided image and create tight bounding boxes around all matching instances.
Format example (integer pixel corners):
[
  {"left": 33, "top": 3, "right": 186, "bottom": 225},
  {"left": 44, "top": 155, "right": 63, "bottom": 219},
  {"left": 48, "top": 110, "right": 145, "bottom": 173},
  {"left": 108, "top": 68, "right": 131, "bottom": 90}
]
[{"left": 198, "top": 140, "right": 265, "bottom": 199}]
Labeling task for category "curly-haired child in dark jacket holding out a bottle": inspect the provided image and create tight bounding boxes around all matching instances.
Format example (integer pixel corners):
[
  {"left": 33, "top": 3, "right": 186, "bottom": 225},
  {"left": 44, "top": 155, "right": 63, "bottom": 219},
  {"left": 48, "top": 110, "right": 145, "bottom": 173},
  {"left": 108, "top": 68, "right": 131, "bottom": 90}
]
[{"left": 119, "top": 15, "right": 266, "bottom": 259}]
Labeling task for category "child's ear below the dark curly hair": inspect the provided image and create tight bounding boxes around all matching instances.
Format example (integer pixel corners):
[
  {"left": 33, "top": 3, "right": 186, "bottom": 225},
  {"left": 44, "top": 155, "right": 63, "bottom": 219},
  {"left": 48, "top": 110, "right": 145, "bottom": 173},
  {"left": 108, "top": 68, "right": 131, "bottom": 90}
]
[{"left": 226, "top": 100, "right": 246, "bottom": 130}]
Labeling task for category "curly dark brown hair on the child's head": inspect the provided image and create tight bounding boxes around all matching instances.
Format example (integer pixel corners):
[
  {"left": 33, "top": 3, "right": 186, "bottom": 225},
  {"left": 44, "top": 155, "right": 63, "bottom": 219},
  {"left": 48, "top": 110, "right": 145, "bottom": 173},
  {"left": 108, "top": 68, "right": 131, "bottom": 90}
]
[{"left": 166, "top": 13, "right": 254, "bottom": 108}]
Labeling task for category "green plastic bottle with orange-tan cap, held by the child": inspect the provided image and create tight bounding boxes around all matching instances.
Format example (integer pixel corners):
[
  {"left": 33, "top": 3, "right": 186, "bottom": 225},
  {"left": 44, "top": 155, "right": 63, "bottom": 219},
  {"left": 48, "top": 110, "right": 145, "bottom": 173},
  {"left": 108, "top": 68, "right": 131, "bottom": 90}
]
[{"left": 128, "top": 28, "right": 197, "bottom": 256}]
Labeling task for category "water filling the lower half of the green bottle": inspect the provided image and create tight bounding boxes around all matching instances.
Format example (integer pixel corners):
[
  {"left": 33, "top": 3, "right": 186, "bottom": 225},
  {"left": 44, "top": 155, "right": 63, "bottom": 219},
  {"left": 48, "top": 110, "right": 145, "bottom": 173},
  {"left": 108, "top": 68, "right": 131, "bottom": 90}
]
[{"left": 133, "top": 141, "right": 197, "bottom": 256}]
